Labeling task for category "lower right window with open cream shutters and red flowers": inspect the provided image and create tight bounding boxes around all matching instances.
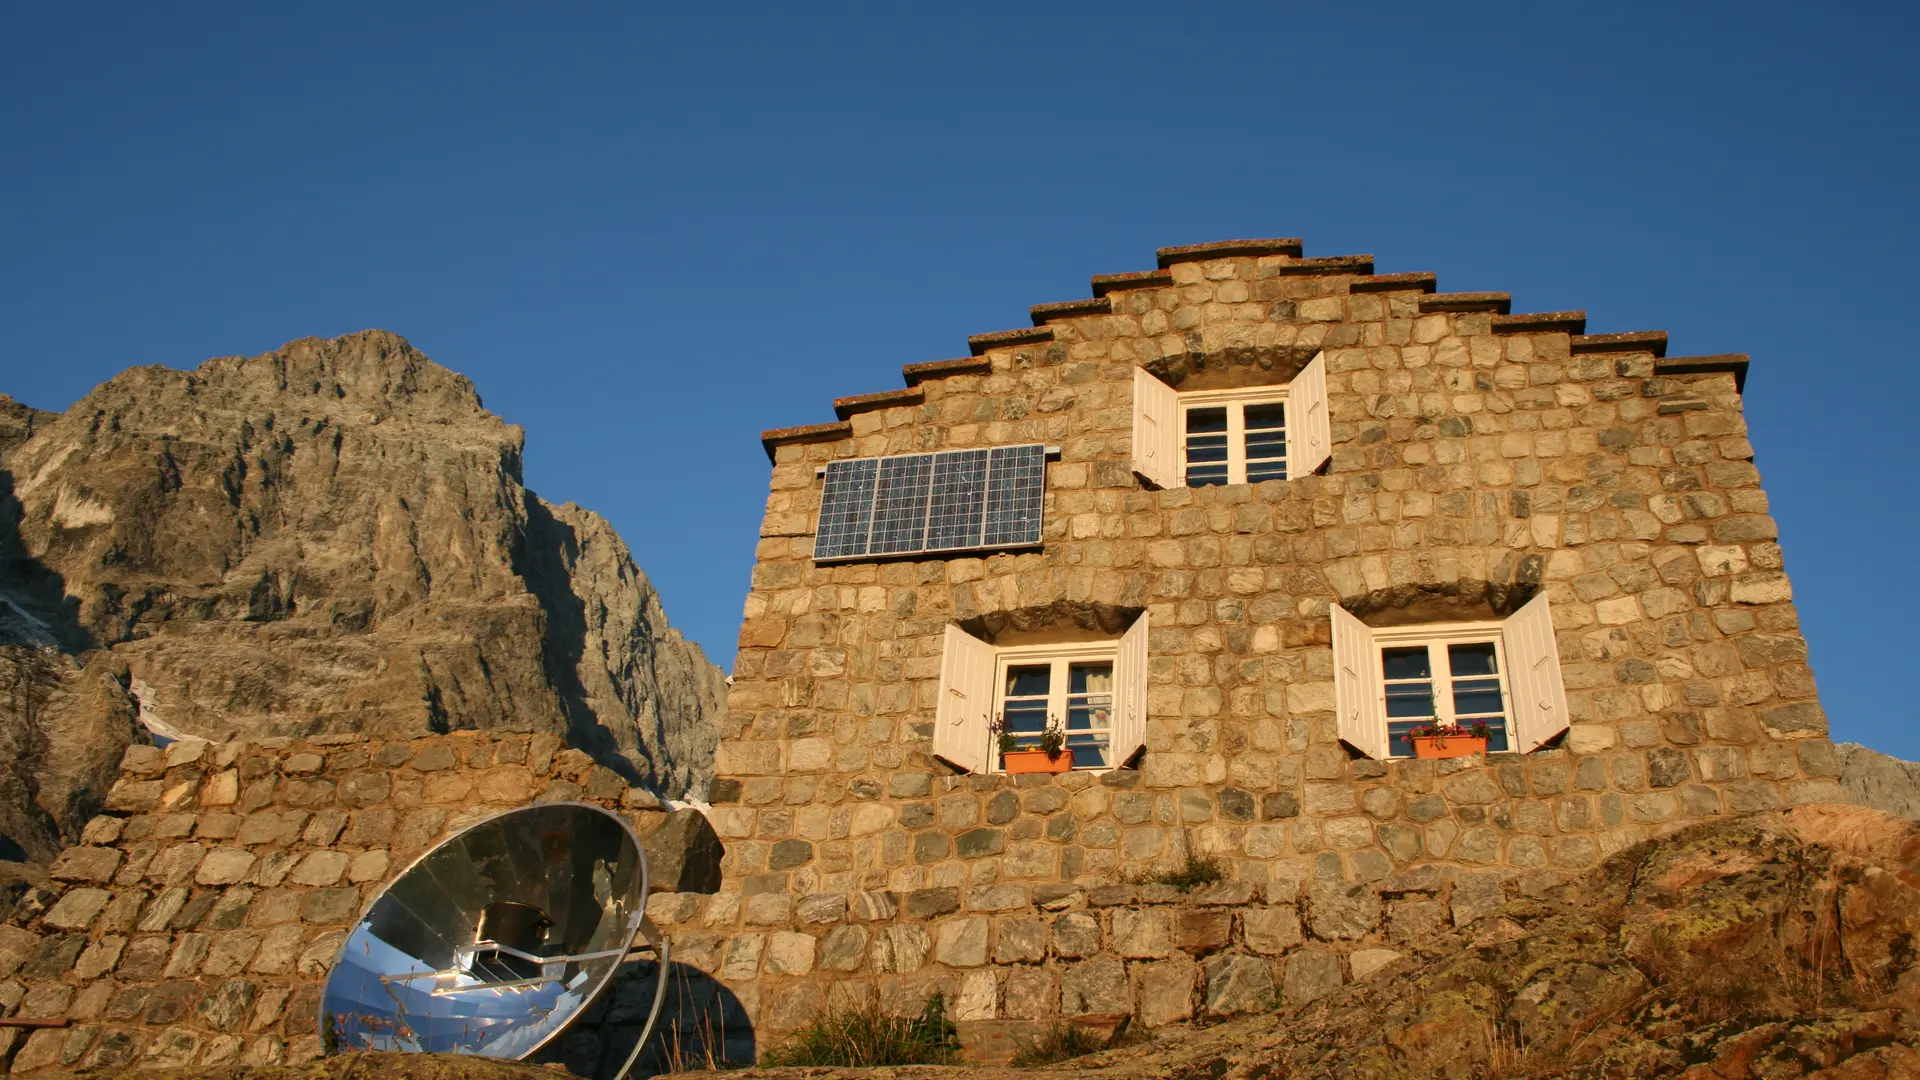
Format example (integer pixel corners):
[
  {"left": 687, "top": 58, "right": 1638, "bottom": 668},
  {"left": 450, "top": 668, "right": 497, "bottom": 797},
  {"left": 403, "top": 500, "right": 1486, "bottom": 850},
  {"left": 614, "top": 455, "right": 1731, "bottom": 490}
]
[{"left": 1332, "top": 592, "right": 1567, "bottom": 757}]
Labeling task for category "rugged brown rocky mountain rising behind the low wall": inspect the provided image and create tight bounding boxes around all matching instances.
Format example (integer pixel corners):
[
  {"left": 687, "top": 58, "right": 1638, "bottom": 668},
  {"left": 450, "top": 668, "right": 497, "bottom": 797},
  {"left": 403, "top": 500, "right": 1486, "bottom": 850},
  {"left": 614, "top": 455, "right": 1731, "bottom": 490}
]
[{"left": 0, "top": 331, "right": 724, "bottom": 853}]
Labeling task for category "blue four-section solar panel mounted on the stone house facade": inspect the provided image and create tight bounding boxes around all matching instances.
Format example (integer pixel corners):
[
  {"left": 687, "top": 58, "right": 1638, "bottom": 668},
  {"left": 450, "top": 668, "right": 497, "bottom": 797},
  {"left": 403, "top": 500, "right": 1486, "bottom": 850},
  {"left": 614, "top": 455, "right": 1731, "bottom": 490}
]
[{"left": 814, "top": 444, "right": 1046, "bottom": 561}]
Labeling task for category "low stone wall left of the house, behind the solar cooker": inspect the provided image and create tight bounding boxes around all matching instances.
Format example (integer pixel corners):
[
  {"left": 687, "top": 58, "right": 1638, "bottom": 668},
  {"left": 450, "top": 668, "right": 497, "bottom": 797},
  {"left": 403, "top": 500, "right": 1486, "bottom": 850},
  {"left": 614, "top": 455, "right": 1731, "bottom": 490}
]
[{"left": 0, "top": 734, "right": 675, "bottom": 1074}]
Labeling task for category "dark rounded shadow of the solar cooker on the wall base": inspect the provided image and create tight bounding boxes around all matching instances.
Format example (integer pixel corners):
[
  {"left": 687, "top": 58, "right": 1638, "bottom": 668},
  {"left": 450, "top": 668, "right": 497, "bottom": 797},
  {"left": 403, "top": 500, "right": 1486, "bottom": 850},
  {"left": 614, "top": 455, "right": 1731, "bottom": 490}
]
[{"left": 534, "top": 961, "right": 758, "bottom": 1080}]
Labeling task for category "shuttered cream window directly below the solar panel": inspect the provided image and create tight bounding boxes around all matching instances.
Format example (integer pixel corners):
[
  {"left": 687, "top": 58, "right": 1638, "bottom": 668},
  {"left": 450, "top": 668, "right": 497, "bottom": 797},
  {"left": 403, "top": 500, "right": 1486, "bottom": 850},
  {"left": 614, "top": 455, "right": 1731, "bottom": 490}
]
[{"left": 933, "top": 615, "right": 1148, "bottom": 773}]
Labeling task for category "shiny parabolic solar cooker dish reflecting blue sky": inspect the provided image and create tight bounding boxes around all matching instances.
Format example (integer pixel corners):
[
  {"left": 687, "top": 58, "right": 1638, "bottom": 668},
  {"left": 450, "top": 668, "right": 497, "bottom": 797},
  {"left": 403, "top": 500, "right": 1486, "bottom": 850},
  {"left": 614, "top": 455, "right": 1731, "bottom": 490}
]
[{"left": 321, "top": 803, "right": 668, "bottom": 1076}]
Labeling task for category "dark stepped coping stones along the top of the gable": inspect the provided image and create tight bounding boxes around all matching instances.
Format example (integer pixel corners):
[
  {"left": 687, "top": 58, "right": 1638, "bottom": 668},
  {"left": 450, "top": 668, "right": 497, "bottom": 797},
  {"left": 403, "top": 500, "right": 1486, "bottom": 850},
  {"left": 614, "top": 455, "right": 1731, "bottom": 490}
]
[{"left": 760, "top": 236, "right": 1749, "bottom": 459}]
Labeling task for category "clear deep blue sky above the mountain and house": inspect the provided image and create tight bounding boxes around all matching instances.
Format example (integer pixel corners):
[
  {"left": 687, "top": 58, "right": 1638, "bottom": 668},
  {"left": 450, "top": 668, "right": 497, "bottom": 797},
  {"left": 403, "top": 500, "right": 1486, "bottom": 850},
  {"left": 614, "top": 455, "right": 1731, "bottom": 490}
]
[{"left": 0, "top": 2, "right": 1920, "bottom": 757}]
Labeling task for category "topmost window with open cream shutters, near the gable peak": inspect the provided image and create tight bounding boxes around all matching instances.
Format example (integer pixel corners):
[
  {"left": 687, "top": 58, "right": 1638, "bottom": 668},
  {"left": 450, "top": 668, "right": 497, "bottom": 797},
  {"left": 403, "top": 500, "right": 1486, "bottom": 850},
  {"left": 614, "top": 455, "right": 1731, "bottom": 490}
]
[{"left": 1133, "top": 356, "right": 1332, "bottom": 488}]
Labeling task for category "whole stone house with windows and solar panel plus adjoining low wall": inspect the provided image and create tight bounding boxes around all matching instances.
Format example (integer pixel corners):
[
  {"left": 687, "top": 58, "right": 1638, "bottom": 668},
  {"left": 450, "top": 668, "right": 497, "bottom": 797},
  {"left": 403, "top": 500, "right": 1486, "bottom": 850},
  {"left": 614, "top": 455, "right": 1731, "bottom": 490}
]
[{"left": 0, "top": 240, "right": 1845, "bottom": 1074}]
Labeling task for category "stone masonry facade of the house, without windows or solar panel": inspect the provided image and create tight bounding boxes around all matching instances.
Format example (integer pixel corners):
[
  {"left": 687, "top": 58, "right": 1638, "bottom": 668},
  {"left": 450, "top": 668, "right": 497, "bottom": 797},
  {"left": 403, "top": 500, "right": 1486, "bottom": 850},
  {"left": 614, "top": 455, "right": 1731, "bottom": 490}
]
[{"left": 718, "top": 242, "right": 1841, "bottom": 1040}]
